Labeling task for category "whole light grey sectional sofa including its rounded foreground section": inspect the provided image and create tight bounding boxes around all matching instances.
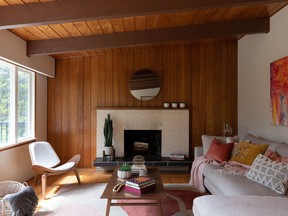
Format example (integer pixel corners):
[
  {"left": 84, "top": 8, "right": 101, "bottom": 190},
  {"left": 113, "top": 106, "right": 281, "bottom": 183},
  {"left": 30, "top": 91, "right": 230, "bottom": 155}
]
[{"left": 193, "top": 134, "right": 288, "bottom": 216}]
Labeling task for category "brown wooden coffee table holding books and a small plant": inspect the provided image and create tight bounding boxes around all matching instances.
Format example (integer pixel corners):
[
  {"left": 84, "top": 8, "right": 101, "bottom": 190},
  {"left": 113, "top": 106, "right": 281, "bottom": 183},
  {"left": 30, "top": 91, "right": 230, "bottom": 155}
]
[{"left": 101, "top": 167, "right": 167, "bottom": 216}]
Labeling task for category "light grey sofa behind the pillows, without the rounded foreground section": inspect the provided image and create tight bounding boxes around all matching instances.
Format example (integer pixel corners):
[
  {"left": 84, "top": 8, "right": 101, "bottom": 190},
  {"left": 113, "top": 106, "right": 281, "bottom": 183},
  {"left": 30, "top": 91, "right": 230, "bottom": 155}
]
[{"left": 202, "top": 134, "right": 288, "bottom": 196}]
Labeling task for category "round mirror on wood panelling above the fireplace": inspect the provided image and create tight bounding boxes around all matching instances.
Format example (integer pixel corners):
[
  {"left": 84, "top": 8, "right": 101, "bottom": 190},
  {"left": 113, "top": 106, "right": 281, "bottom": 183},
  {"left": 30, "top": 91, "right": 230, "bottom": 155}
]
[{"left": 130, "top": 69, "right": 161, "bottom": 101}]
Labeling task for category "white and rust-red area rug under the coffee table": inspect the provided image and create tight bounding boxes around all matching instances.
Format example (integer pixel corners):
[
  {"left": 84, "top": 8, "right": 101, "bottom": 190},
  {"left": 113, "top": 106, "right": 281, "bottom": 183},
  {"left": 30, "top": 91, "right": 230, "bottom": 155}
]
[{"left": 35, "top": 184, "right": 205, "bottom": 216}]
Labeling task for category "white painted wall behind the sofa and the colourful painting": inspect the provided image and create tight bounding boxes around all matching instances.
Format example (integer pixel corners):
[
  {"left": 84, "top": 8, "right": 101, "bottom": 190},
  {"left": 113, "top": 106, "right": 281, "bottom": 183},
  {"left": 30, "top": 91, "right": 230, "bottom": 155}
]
[{"left": 238, "top": 6, "right": 288, "bottom": 143}]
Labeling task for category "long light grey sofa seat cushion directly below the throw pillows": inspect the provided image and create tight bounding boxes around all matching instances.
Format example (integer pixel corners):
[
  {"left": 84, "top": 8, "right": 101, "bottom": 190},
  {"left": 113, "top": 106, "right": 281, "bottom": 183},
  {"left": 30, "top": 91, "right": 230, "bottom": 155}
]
[{"left": 203, "top": 164, "right": 286, "bottom": 196}]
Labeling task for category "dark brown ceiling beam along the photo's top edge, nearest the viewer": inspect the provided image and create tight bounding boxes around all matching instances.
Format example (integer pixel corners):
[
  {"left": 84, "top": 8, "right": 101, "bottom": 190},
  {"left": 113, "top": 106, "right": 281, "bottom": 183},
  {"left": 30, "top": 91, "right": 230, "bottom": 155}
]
[{"left": 0, "top": 0, "right": 288, "bottom": 30}]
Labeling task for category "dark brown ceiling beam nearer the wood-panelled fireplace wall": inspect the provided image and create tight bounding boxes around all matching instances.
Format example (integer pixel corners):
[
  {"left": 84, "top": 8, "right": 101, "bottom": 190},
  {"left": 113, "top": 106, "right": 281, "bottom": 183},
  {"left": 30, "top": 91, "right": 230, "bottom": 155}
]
[{"left": 27, "top": 18, "right": 269, "bottom": 56}]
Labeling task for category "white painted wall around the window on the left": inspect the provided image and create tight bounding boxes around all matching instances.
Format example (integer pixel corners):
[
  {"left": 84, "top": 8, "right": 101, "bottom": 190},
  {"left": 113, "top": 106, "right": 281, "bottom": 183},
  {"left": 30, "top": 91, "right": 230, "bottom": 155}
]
[{"left": 0, "top": 31, "right": 55, "bottom": 182}]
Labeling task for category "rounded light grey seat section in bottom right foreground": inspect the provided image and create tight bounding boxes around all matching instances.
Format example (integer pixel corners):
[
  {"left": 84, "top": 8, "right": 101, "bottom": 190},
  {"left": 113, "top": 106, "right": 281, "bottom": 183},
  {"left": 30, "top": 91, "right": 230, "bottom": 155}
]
[{"left": 193, "top": 195, "right": 288, "bottom": 216}]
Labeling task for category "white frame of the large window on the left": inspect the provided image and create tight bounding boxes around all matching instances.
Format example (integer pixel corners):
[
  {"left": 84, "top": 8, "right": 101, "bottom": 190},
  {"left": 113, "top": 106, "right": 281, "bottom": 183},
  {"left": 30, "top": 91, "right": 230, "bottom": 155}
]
[{"left": 0, "top": 57, "right": 36, "bottom": 151}]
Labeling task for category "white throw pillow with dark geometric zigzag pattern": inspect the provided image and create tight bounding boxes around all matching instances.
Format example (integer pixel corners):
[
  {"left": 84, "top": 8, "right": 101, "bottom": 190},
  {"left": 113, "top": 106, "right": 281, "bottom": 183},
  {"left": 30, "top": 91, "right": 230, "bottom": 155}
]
[{"left": 246, "top": 154, "right": 288, "bottom": 194}]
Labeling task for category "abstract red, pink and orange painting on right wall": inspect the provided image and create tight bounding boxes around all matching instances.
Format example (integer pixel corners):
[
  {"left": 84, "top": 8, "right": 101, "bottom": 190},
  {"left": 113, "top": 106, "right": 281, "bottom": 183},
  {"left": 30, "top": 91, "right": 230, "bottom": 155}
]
[{"left": 270, "top": 56, "right": 288, "bottom": 126}]
